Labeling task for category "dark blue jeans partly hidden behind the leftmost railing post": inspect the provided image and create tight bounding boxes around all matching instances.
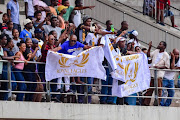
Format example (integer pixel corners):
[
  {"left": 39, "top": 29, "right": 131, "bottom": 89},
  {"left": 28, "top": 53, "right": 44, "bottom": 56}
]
[{"left": 1, "top": 64, "right": 17, "bottom": 100}]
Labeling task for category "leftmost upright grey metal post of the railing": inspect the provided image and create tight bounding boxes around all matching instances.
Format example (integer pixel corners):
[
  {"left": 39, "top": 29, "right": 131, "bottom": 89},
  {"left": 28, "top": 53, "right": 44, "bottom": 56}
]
[{"left": 7, "top": 62, "right": 12, "bottom": 101}]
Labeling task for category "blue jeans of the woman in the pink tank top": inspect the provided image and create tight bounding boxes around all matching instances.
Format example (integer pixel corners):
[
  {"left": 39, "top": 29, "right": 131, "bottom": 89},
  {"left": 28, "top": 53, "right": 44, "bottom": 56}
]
[{"left": 13, "top": 68, "right": 26, "bottom": 101}]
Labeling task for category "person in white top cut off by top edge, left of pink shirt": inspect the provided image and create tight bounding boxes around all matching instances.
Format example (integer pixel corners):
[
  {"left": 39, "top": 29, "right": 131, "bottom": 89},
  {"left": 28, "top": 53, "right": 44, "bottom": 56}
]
[{"left": 24, "top": 0, "right": 34, "bottom": 20}]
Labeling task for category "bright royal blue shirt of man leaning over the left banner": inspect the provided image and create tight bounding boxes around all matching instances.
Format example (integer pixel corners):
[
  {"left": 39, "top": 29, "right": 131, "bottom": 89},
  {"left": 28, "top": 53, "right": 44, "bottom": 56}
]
[{"left": 58, "top": 41, "right": 84, "bottom": 55}]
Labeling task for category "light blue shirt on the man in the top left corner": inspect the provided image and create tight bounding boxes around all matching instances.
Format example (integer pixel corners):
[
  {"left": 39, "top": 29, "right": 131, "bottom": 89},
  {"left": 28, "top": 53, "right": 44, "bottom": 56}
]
[{"left": 7, "top": 0, "right": 19, "bottom": 24}]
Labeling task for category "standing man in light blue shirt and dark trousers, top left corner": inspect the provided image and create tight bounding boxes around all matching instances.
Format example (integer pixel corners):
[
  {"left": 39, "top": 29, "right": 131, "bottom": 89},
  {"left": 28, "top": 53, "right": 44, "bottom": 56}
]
[{"left": 7, "top": 0, "right": 21, "bottom": 33}]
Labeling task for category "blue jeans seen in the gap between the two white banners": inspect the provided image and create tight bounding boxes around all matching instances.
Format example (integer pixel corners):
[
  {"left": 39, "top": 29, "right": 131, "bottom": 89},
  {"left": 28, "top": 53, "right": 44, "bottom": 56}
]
[{"left": 100, "top": 68, "right": 117, "bottom": 104}]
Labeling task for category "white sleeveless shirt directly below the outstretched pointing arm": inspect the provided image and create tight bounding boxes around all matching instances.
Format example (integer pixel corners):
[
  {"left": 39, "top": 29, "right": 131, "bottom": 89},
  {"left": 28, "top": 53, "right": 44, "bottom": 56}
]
[{"left": 73, "top": 10, "right": 81, "bottom": 27}]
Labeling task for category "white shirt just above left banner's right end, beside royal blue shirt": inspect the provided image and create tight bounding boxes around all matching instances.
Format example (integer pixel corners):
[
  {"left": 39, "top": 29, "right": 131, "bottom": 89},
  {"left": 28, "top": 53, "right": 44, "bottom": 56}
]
[{"left": 85, "top": 33, "right": 99, "bottom": 46}]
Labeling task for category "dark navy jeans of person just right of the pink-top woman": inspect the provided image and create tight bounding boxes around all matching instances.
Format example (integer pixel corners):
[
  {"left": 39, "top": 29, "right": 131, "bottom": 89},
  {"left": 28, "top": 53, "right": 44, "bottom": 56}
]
[{"left": 23, "top": 69, "right": 37, "bottom": 101}]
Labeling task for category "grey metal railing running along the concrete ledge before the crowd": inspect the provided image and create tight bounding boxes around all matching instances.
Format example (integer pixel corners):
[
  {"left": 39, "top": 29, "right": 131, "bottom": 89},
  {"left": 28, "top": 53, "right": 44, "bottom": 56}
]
[{"left": 0, "top": 60, "right": 180, "bottom": 105}]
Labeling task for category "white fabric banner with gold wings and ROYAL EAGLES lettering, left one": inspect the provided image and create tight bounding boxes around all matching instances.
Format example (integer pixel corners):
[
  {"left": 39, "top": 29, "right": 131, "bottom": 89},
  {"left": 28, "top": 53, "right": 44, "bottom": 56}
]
[{"left": 45, "top": 47, "right": 106, "bottom": 81}]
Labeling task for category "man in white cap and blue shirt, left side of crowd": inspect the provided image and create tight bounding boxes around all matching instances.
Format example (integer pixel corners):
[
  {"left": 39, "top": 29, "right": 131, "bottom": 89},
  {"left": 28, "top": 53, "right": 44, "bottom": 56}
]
[{"left": 20, "top": 19, "right": 33, "bottom": 42}]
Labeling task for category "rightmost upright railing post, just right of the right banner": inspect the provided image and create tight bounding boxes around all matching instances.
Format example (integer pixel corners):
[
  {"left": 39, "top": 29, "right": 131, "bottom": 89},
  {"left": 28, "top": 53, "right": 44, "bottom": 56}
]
[{"left": 154, "top": 69, "right": 158, "bottom": 106}]
